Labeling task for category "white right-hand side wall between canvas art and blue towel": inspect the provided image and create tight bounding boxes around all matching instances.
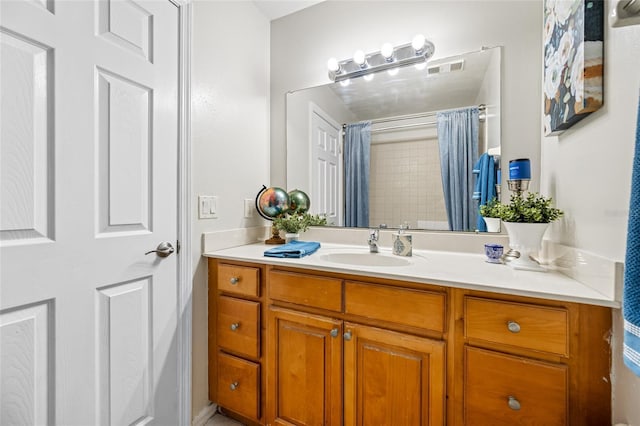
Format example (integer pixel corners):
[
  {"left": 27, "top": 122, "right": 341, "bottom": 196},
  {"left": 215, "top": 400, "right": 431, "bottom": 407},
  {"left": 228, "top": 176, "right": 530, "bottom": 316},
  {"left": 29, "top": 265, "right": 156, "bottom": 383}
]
[{"left": 539, "top": 6, "right": 640, "bottom": 425}]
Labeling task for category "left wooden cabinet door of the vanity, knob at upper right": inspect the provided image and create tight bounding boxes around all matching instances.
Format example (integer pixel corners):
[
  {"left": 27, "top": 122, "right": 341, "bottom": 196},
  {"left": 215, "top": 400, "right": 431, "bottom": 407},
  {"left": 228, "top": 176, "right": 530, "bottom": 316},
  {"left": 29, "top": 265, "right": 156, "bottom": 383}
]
[{"left": 267, "top": 307, "right": 342, "bottom": 426}]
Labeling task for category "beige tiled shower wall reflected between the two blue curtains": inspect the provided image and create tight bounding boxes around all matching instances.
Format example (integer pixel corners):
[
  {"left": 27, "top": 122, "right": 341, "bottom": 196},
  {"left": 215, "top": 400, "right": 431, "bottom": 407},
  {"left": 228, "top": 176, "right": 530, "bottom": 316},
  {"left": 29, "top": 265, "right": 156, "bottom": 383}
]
[{"left": 369, "top": 136, "right": 447, "bottom": 229}]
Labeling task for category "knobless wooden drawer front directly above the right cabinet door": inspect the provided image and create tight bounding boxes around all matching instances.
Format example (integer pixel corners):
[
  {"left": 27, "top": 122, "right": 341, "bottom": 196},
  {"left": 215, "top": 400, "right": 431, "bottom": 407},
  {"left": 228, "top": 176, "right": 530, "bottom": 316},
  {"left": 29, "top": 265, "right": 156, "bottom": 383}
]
[{"left": 344, "top": 281, "right": 446, "bottom": 333}]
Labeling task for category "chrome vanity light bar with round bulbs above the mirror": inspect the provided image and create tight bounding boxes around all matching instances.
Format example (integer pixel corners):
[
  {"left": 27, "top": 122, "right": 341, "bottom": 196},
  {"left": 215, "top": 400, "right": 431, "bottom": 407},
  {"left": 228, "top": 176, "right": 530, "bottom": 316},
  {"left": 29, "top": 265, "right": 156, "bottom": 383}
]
[{"left": 327, "top": 35, "right": 435, "bottom": 82}]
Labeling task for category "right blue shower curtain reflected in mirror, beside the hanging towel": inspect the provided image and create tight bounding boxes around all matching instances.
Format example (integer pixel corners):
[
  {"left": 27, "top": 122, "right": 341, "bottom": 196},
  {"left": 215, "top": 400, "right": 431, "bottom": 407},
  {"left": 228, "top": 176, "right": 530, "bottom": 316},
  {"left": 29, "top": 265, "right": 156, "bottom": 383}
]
[{"left": 438, "top": 107, "right": 479, "bottom": 231}]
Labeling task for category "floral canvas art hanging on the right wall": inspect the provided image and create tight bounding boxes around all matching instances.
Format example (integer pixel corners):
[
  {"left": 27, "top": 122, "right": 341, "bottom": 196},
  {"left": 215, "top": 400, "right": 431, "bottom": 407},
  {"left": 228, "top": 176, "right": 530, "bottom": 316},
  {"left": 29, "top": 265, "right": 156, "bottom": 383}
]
[{"left": 543, "top": 0, "right": 604, "bottom": 136}]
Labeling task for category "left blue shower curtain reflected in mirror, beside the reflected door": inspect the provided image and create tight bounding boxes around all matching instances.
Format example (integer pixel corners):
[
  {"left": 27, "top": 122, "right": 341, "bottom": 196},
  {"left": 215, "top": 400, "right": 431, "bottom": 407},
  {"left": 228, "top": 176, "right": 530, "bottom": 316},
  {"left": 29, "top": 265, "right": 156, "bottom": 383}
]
[{"left": 344, "top": 121, "right": 371, "bottom": 228}]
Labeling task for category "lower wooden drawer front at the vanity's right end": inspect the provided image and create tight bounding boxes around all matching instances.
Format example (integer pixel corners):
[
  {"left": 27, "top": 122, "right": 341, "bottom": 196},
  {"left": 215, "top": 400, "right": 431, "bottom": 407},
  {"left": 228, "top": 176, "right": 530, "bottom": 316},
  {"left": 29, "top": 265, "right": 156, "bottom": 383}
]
[{"left": 464, "top": 347, "right": 568, "bottom": 426}]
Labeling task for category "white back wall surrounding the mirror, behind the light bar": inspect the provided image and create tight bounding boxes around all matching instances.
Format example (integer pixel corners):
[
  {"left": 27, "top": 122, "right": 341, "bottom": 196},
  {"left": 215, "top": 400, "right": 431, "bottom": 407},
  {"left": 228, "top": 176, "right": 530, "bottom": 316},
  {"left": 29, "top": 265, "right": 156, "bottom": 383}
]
[{"left": 271, "top": 0, "right": 542, "bottom": 188}]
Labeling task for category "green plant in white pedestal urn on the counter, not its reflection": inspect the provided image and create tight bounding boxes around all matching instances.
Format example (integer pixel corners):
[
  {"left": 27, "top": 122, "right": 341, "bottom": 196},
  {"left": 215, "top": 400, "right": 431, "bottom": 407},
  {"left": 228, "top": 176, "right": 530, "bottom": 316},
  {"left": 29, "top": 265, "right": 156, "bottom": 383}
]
[{"left": 500, "top": 192, "right": 564, "bottom": 271}]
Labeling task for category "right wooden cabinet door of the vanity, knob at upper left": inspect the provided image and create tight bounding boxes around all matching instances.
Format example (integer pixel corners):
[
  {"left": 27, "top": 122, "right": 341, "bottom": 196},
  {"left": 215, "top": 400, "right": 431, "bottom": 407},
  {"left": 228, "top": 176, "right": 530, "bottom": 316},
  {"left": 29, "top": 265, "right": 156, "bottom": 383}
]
[{"left": 344, "top": 323, "right": 445, "bottom": 426}]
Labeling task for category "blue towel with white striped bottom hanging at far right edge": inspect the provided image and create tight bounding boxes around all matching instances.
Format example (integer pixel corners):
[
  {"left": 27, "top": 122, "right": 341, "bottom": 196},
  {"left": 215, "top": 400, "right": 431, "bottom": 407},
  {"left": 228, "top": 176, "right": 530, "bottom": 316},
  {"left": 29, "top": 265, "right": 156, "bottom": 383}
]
[{"left": 622, "top": 92, "right": 640, "bottom": 376}]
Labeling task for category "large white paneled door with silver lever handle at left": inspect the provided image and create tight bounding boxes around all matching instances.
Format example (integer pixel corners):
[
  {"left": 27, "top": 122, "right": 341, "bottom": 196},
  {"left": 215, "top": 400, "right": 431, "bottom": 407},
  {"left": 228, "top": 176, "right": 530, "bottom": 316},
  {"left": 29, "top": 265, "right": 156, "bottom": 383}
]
[{"left": 0, "top": 0, "right": 179, "bottom": 426}]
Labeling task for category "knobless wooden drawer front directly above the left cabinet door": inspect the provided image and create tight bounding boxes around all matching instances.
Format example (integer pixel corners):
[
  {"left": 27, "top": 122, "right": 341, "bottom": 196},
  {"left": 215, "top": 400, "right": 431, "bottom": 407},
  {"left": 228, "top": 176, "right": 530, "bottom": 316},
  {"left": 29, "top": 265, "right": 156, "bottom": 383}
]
[{"left": 269, "top": 271, "right": 342, "bottom": 312}]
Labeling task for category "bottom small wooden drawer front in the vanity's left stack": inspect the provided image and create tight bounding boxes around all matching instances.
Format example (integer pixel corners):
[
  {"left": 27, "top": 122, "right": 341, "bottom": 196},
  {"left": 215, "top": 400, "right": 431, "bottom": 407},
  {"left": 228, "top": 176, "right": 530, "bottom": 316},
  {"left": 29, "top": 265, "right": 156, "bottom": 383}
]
[{"left": 217, "top": 353, "right": 260, "bottom": 420}]
